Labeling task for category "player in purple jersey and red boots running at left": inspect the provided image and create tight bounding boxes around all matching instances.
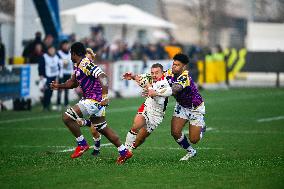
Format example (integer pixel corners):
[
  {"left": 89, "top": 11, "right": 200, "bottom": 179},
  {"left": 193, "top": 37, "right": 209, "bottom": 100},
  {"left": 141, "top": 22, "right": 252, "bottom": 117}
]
[{"left": 51, "top": 42, "right": 132, "bottom": 164}]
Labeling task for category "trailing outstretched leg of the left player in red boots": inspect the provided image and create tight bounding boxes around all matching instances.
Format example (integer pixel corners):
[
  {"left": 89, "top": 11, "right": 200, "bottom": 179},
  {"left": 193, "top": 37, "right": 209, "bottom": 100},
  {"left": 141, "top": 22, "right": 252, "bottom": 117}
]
[{"left": 90, "top": 116, "right": 132, "bottom": 164}]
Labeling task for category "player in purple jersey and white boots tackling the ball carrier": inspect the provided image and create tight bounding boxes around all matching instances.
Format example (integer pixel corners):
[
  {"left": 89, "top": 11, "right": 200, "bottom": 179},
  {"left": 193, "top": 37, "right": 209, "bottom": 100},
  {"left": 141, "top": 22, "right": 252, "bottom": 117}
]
[{"left": 162, "top": 54, "right": 205, "bottom": 161}]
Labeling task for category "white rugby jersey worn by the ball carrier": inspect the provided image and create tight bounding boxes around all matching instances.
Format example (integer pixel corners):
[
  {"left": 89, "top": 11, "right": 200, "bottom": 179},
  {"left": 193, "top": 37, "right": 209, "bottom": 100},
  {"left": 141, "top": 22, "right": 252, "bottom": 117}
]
[{"left": 144, "top": 76, "right": 172, "bottom": 113}]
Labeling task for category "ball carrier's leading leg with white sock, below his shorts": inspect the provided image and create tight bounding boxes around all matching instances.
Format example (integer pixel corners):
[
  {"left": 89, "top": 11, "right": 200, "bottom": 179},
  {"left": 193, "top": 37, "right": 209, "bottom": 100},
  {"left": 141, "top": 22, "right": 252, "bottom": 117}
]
[{"left": 125, "top": 114, "right": 146, "bottom": 149}]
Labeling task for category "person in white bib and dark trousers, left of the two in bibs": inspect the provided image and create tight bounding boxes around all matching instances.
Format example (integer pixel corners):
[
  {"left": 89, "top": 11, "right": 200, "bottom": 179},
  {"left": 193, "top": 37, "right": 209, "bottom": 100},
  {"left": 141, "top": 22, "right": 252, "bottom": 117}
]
[{"left": 38, "top": 46, "right": 62, "bottom": 111}]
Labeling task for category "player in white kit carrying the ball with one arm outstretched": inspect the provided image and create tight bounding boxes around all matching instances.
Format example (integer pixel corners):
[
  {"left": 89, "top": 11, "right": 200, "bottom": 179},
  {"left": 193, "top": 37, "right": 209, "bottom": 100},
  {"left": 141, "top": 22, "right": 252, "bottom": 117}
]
[{"left": 123, "top": 63, "right": 172, "bottom": 150}]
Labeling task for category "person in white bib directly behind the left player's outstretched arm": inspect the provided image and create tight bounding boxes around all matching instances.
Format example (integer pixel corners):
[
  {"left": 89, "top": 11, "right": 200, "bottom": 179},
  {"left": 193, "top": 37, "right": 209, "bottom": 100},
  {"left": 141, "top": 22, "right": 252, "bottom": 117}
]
[{"left": 57, "top": 40, "right": 73, "bottom": 110}]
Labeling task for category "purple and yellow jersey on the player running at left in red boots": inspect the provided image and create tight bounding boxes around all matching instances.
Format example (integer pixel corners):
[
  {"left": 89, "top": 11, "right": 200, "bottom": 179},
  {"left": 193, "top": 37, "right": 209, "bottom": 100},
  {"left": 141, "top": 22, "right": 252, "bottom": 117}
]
[{"left": 74, "top": 57, "right": 104, "bottom": 102}]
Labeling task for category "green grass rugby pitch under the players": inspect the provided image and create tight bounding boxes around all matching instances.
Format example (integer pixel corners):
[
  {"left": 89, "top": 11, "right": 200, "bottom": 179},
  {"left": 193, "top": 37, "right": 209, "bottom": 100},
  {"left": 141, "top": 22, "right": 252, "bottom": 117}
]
[{"left": 0, "top": 89, "right": 284, "bottom": 189}]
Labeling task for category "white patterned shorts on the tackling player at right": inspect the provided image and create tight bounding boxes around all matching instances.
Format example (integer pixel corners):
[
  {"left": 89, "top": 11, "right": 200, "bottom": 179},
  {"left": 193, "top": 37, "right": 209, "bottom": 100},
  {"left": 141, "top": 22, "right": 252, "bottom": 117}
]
[{"left": 173, "top": 103, "right": 205, "bottom": 127}]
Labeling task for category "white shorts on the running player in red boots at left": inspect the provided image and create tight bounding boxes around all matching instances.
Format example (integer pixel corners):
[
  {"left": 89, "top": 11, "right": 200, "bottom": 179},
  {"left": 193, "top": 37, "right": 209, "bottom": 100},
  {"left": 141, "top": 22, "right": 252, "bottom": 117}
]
[{"left": 77, "top": 99, "right": 105, "bottom": 117}]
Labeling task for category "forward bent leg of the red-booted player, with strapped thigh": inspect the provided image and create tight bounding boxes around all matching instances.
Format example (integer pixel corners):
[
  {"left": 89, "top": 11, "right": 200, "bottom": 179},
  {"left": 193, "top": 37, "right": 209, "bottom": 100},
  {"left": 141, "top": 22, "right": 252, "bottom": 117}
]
[{"left": 62, "top": 105, "right": 89, "bottom": 158}]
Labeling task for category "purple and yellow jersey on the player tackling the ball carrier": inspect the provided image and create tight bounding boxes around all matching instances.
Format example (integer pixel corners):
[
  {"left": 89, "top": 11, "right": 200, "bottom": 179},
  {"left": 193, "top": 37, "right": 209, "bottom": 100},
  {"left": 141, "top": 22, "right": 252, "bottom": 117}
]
[{"left": 165, "top": 69, "right": 203, "bottom": 108}]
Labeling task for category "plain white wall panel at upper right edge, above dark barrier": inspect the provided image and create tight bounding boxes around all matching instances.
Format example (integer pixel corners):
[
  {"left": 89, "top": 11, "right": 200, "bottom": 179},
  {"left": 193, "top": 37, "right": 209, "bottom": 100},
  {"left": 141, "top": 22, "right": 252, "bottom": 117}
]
[{"left": 246, "top": 23, "right": 284, "bottom": 51}]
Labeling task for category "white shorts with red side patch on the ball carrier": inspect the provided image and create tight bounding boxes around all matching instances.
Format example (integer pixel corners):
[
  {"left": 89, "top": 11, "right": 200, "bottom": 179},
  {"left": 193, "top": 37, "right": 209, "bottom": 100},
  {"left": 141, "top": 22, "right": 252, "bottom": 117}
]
[{"left": 137, "top": 104, "right": 164, "bottom": 133}]
